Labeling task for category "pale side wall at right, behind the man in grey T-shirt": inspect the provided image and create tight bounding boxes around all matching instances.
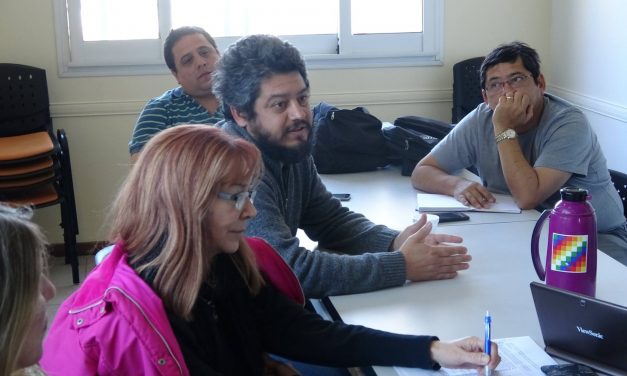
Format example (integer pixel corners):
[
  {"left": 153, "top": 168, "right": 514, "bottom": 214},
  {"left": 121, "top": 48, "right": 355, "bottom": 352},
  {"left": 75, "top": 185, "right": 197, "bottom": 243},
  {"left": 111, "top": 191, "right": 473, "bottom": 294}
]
[{"left": 548, "top": 0, "right": 627, "bottom": 172}]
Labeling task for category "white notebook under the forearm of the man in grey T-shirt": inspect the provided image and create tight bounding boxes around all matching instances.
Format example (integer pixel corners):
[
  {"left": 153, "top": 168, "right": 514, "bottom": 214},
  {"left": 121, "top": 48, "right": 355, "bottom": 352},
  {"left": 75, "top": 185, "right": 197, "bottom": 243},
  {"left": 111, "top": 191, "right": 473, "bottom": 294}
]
[{"left": 416, "top": 193, "right": 521, "bottom": 213}]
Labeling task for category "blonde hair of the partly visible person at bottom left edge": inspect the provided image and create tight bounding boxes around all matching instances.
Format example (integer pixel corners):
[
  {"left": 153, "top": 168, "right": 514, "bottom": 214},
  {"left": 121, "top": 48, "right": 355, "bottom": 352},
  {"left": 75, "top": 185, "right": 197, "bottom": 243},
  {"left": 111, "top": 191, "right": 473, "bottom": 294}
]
[{"left": 0, "top": 203, "right": 47, "bottom": 375}]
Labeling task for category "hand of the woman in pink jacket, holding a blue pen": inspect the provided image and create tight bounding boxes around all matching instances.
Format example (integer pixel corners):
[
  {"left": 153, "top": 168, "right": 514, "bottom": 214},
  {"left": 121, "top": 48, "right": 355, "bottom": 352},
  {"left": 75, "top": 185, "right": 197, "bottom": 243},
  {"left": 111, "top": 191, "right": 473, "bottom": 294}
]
[{"left": 431, "top": 337, "right": 501, "bottom": 374}]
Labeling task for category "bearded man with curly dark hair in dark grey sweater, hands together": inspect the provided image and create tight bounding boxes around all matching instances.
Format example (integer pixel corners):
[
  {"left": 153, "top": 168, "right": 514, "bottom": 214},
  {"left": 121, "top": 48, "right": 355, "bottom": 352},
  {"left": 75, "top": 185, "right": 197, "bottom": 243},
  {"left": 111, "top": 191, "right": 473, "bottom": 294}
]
[{"left": 213, "top": 35, "right": 471, "bottom": 298}]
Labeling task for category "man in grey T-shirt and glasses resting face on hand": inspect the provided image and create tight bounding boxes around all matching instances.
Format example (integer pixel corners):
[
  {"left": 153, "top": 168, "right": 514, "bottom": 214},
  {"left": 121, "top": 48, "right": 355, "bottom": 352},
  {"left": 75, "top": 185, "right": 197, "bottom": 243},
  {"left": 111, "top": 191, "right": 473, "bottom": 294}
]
[{"left": 411, "top": 42, "right": 627, "bottom": 264}]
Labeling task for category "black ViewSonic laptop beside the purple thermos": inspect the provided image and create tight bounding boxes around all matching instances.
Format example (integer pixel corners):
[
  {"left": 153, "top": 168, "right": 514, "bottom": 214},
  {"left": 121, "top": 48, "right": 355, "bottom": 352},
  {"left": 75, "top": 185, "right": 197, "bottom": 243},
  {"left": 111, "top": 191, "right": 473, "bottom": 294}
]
[{"left": 530, "top": 282, "right": 627, "bottom": 375}]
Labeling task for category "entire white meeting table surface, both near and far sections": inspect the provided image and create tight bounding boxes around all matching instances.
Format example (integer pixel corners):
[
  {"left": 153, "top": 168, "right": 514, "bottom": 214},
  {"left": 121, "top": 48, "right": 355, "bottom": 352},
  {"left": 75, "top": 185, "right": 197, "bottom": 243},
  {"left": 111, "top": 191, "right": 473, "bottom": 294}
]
[{"left": 312, "top": 169, "right": 627, "bottom": 375}]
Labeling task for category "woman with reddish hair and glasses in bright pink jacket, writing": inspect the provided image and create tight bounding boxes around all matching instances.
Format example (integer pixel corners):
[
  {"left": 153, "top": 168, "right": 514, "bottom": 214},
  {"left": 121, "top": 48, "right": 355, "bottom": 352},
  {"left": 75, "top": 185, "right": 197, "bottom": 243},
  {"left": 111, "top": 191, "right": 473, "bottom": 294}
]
[{"left": 41, "top": 125, "right": 499, "bottom": 376}]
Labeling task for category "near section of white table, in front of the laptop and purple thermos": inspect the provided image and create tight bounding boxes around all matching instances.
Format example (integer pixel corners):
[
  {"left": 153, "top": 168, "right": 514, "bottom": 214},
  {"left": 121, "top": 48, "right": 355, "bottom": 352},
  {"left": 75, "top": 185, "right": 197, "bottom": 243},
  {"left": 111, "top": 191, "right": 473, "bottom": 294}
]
[{"left": 330, "top": 222, "right": 627, "bottom": 375}]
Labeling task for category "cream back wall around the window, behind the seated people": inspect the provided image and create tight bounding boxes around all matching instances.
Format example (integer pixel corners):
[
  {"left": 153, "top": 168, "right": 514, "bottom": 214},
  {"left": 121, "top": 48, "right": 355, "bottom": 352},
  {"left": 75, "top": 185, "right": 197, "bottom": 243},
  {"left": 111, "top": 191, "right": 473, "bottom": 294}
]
[{"left": 0, "top": 0, "right": 552, "bottom": 242}]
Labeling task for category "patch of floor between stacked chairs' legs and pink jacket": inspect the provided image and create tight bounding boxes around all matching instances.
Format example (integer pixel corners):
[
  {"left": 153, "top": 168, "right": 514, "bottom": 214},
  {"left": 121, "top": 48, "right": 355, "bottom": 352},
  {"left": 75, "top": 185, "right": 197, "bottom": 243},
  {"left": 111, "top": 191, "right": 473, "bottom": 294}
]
[{"left": 48, "top": 255, "right": 94, "bottom": 323}]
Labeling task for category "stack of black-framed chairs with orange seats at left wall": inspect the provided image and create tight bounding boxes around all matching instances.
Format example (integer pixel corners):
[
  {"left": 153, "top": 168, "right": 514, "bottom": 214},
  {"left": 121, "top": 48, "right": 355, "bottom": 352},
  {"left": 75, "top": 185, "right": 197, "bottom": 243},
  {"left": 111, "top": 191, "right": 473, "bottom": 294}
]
[{"left": 0, "top": 63, "right": 79, "bottom": 283}]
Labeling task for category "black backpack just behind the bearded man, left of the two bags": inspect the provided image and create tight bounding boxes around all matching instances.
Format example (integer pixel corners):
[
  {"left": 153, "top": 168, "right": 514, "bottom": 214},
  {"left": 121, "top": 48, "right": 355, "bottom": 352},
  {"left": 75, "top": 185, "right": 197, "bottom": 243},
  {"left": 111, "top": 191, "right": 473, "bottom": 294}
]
[{"left": 312, "top": 102, "right": 388, "bottom": 174}]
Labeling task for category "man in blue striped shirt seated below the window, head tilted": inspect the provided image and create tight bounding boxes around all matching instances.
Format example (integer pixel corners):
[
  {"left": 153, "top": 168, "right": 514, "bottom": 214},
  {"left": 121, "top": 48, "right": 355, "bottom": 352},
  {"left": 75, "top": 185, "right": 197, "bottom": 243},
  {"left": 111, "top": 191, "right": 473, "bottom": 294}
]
[{"left": 129, "top": 26, "right": 224, "bottom": 162}]
